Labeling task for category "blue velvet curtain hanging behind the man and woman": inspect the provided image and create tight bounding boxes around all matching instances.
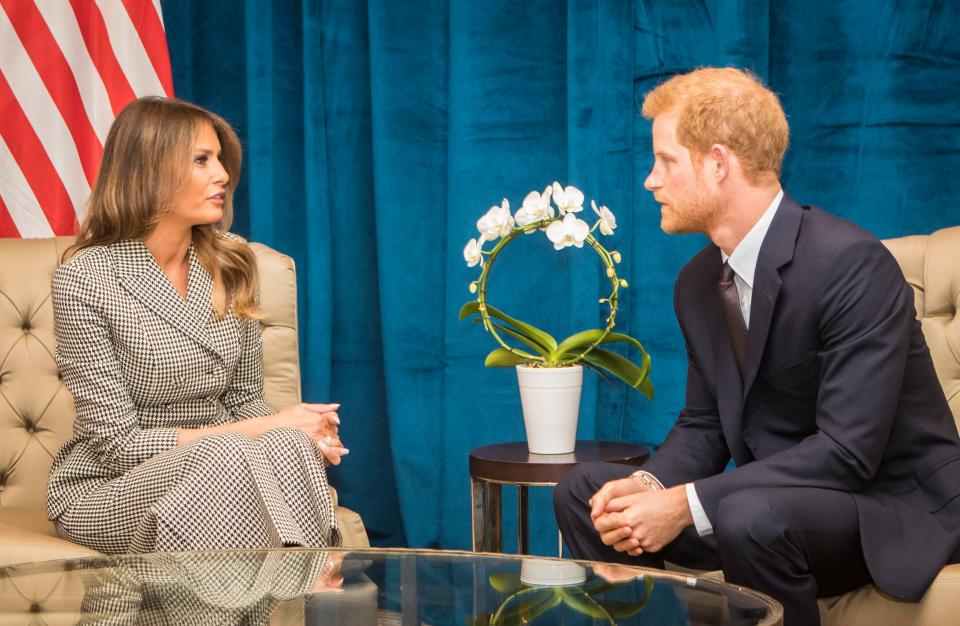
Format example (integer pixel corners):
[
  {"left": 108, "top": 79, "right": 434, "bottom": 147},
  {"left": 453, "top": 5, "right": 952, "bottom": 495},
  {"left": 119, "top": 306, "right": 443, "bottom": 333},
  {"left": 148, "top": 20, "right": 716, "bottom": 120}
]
[{"left": 162, "top": 0, "right": 960, "bottom": 553}]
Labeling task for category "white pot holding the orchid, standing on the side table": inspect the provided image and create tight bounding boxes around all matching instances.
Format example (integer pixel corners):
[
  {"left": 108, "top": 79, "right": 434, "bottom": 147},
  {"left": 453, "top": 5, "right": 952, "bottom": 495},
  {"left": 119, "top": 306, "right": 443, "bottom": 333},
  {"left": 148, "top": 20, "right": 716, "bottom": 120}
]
[{"left": 517, "top": 365, "right": 583, "bottom": 454}]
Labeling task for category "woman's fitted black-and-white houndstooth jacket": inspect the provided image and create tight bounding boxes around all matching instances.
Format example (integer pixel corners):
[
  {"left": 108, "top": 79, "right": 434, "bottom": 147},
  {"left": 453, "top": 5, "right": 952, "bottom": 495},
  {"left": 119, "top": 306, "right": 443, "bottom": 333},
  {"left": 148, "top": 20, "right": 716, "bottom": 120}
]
[{"left": 47, "top": 235, "right": 275, "bottom": 520}]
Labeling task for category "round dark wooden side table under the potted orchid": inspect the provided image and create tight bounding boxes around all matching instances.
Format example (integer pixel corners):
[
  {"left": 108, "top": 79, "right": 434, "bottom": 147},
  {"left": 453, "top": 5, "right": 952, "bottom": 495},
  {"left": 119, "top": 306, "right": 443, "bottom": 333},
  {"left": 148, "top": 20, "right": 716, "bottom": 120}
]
[{"left": 470, "top": 441, "right": 650, "bottom": 554}]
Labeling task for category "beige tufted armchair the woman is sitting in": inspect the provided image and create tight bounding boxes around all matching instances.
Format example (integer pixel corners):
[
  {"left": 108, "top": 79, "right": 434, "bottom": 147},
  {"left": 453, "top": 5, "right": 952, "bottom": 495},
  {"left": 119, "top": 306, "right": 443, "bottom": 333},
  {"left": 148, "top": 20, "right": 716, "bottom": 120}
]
[{"left": 0, "top": 238, "right": 370, "bottom": 565}]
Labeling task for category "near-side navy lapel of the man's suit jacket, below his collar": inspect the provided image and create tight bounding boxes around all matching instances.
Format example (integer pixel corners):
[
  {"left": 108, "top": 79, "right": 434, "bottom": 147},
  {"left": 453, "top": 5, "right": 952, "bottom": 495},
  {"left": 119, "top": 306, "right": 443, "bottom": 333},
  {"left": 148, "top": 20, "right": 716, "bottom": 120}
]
[{"left": 743, "top": 193, "right": 803, "bottom": 398}]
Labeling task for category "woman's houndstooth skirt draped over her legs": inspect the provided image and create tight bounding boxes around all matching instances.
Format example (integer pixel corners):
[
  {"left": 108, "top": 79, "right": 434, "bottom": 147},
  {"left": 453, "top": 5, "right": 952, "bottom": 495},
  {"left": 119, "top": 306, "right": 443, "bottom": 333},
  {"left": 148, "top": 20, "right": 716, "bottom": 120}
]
[{"left": 56, "top": 428, "right": 341, "bottom": 554}]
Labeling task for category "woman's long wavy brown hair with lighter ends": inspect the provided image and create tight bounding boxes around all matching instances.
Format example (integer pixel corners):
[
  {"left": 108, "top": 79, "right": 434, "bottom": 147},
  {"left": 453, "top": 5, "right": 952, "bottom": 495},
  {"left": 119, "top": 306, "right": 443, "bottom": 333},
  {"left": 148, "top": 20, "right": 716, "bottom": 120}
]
[{"left": 64, "top": 96, "right": 259, "bottom": 318}]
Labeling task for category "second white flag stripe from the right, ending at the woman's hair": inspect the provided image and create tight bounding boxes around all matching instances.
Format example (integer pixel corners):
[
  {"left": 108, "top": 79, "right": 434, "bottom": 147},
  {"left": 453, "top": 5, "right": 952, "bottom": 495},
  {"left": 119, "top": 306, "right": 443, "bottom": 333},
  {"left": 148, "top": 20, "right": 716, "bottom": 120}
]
[{"left": 36, "top": 0, "right": 113, "bottom": 145}]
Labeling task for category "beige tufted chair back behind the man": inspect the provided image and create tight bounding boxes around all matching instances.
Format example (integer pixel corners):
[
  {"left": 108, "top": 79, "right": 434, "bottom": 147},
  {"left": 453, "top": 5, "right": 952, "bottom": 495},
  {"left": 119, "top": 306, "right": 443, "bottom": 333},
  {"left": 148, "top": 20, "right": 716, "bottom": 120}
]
[{"left": 884, "top": 226, "right": 960, "bottom": 427}]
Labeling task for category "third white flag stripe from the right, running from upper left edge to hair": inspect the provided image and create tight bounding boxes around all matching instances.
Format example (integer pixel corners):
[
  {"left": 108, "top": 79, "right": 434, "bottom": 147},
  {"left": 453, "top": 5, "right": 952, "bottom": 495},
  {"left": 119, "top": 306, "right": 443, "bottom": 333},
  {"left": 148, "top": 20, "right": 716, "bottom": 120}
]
[{"left": 0, "top": 10, "right": 90, "bottom": 212}]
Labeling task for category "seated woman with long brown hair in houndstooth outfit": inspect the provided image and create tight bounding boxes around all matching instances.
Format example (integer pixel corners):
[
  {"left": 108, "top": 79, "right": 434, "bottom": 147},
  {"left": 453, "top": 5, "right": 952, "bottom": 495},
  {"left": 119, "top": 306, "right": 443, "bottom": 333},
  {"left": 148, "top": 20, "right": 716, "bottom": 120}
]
[{"left": 47, "top": 97, "right": 347, "bottom": 553}]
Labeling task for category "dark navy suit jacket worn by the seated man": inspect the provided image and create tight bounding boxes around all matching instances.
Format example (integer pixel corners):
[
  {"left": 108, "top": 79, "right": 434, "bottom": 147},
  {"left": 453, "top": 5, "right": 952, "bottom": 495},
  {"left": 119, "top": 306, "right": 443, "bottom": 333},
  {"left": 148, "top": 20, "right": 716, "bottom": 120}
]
[{"left": 645, "top": 194, "right": 960, "bottom": 600}]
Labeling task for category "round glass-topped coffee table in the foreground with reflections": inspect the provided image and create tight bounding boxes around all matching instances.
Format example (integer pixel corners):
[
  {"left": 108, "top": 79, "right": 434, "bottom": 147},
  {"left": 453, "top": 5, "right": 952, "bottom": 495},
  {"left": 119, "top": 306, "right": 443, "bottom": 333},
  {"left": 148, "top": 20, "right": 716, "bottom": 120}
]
[{"left": 0, "top": 549, "right": 783, "bottom": 626}]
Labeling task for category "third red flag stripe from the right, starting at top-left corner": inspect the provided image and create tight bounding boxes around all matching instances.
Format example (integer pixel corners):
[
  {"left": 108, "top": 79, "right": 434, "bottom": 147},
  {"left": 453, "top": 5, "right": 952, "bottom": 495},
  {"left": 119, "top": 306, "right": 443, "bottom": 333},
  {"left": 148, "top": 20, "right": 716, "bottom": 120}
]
[{"left": 0, "top": 0, "right": 103, "bottom": 186}]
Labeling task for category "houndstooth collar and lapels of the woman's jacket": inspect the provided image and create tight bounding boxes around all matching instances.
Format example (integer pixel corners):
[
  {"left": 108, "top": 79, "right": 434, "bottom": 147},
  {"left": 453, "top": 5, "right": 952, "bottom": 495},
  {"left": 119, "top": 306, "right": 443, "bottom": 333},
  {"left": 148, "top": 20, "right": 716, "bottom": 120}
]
[{"left": 110, "top": 240, "right": 218, "bottom": 354}]
